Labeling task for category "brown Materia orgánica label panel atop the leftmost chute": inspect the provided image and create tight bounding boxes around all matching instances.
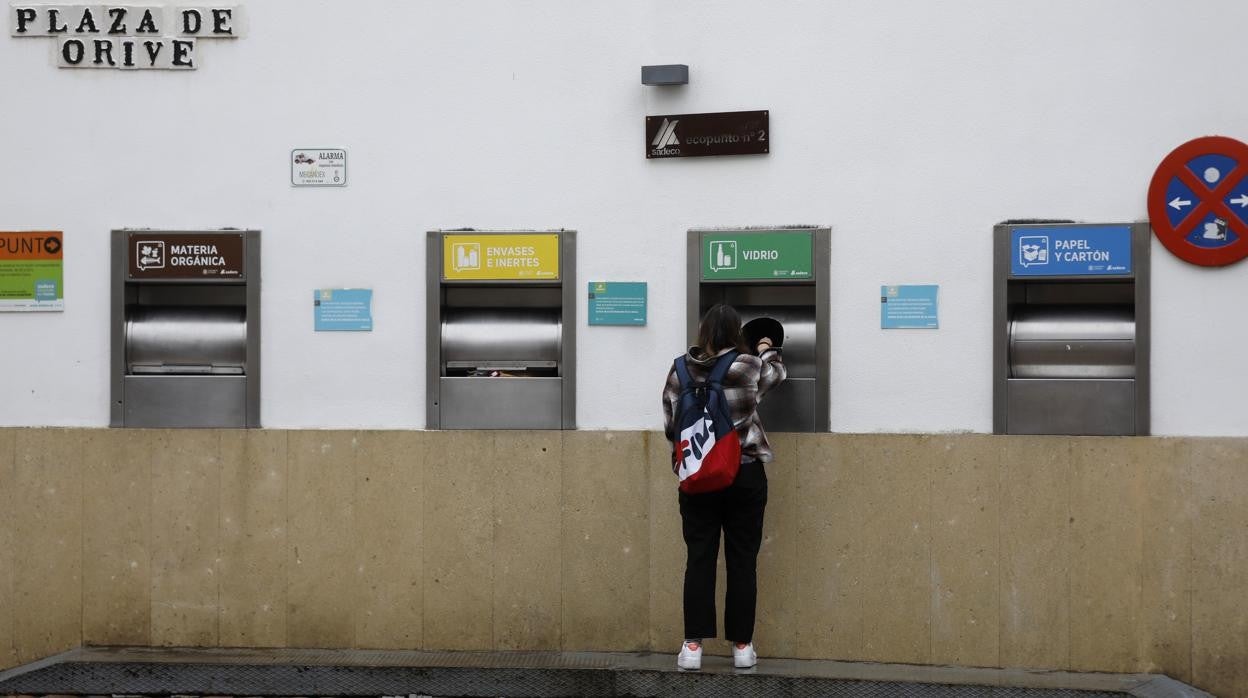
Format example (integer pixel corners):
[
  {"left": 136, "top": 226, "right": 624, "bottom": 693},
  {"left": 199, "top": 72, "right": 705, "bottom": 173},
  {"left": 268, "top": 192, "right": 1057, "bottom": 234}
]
[{"left": 127, "top": 231, "right": 246, "bottom": 280}]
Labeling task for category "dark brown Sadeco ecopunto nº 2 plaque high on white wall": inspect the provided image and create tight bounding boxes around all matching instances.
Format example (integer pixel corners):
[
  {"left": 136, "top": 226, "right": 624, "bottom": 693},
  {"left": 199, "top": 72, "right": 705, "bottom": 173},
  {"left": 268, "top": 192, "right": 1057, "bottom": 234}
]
[{"left": 645, "top": 111, "right": 771, "bottom": 159}]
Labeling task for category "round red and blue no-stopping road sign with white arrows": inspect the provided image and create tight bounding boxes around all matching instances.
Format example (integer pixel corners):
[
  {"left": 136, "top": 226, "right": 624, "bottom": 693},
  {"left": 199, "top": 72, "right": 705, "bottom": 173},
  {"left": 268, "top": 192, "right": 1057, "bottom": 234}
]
[{"left": 1148, "top": 136, "right": 1248, "bottom": 266}]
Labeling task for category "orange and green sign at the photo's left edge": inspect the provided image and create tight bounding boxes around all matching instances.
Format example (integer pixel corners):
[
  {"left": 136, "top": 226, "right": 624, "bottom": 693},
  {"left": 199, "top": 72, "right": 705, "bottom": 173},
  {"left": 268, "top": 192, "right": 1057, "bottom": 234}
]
[{"left": 0, "top": 231, "right": 65, "bottom": 312}]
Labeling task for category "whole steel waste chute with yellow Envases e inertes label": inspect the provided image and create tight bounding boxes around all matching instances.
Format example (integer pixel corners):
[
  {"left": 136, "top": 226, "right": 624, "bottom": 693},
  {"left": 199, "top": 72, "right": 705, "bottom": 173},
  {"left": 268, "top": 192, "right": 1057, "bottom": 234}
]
[{"left": 424, "top": 230, "right": 577, "bottom": 430}]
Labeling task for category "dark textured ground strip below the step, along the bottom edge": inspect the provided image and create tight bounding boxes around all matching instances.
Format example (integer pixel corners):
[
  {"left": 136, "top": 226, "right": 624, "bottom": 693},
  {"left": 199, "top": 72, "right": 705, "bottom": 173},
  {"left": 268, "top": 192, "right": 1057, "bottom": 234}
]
[{"left": 0, "top": 662, "right": 1123, "bottom": 698}]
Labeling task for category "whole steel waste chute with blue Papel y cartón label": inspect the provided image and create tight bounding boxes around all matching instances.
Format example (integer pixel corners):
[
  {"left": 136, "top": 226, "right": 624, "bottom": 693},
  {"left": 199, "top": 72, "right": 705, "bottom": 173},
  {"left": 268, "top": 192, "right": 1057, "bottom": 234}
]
[{"left": 992, "top": 220, "right": 1152, "bottom": 436}]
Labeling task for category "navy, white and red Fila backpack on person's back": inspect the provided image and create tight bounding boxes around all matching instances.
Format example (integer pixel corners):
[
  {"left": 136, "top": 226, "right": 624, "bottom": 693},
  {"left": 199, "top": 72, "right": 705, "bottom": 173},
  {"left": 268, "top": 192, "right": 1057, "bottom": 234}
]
[{"left": 671, "top": 351, "right": 741, "bottom": 494}]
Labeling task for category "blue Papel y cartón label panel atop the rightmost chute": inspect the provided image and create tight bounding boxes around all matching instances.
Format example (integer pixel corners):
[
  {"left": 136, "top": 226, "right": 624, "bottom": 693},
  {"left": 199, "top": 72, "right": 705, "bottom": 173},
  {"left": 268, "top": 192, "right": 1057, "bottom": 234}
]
[{"left": 1010, "top": 225, "right": 1131, "bottom": 276}]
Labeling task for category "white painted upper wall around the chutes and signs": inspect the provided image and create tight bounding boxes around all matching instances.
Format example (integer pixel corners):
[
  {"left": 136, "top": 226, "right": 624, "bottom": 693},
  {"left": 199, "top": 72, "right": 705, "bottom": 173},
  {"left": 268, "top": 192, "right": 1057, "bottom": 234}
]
[{"left": 0, "top": 0, "right": 1248, "bottom": 435}]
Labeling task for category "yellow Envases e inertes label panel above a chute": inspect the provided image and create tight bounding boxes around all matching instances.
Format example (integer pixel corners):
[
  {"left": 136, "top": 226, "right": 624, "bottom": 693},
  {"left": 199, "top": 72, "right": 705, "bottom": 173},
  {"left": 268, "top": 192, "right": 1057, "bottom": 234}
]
[{"left": 442, "top": 233, "right": 559, "bottom": 281}]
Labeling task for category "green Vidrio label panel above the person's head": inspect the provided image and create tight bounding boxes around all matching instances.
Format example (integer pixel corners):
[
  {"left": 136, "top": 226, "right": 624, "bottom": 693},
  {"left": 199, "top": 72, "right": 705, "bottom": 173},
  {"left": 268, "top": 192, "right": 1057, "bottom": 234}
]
[{"left": 701, "top": 231, "right": 811, "bottom": 281}]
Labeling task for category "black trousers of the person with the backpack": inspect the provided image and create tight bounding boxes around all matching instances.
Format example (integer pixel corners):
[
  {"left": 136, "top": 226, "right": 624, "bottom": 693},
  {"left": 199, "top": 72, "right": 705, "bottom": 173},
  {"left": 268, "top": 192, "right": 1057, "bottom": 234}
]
[{"left": 680, "top": 462, "right": 768, "bottom": 642}]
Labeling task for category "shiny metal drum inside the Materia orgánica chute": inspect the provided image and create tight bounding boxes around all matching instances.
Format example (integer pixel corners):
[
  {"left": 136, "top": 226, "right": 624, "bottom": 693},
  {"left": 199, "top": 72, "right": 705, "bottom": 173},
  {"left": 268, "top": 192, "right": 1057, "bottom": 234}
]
[{"left": 126, "top": 306, "right": 247, "bottom": 375}]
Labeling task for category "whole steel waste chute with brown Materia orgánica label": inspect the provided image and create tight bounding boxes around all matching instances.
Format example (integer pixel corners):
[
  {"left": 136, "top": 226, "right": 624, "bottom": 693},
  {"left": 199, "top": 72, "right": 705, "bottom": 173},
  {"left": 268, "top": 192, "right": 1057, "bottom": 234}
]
[{"left": 109, "top": 229, "right": 261, "bottom": 428}]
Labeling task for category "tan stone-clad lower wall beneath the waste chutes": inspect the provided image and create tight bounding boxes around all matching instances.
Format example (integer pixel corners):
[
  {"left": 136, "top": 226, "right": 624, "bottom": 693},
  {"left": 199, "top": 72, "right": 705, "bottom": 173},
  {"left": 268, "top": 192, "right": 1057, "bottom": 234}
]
[{"left": 0, "top": 428, "right": 1248, "bottom": 696}]
